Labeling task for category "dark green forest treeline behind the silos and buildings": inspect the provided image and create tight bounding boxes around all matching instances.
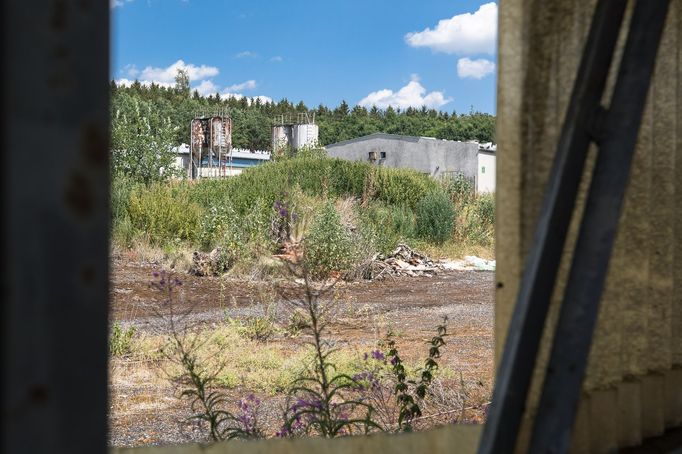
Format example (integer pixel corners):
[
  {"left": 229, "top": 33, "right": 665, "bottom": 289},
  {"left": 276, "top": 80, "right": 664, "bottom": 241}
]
[{"left": 111, "top": 75, "right": 495, "bottom": 150}]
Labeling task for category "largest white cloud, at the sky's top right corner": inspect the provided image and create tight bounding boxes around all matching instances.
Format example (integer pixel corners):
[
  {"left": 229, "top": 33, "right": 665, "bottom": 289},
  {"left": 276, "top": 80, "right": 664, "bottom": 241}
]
[{"left": 405, "top": 3, "right": 497, "bottom": 55}]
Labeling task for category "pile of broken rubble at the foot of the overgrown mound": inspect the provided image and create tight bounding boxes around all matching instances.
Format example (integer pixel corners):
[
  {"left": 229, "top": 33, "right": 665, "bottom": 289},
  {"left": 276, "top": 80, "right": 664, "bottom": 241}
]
[{"left": 365, "top": 244, "right": 438, "bottom": 279}]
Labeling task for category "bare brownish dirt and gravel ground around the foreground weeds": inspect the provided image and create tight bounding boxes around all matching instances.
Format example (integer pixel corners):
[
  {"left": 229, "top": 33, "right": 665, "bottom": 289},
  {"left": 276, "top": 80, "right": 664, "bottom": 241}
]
[{"left": 110, "top": 257, "right": 494, "bottom": 446}]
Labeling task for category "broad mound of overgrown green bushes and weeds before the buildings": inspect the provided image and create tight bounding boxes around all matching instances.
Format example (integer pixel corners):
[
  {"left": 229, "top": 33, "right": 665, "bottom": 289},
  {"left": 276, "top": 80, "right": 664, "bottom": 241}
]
[{"left": 112, "top": 153, "right": 494, "bottom": 278}]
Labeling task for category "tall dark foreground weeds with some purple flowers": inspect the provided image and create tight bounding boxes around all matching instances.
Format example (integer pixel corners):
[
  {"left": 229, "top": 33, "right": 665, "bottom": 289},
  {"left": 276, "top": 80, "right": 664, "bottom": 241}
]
[{"left": 151, "top": 261, "right": 460, "bottom": 441}]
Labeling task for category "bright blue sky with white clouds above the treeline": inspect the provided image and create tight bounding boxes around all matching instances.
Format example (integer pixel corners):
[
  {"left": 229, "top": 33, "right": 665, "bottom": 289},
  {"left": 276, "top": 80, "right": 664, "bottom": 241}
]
[{"left": 110, "top": 0, "right": 497, "bottom": 113}]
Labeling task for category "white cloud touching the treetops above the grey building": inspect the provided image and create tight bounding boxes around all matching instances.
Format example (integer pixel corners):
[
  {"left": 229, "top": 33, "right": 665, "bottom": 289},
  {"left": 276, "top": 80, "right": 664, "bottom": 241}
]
[{"left": 358, "top": 75, "right": 452, "bottom": 109}]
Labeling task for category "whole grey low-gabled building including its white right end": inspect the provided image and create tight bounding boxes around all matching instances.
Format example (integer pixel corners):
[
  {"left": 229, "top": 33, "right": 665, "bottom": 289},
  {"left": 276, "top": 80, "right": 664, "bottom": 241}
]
[{"left": 325, "top": 133, "right": 496, "bottom": 192}]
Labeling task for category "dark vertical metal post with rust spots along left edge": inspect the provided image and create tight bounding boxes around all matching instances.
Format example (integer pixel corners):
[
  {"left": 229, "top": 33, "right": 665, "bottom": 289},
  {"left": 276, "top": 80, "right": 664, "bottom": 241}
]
[{"left": 0, "top": 0, "right": 110, "bottom": 453}]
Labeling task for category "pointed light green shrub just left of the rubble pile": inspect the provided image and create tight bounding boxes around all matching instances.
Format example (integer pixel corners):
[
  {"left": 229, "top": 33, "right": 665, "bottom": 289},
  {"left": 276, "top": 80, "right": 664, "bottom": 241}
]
[{"left": 304, "top": 202, "right": 355, "bottom": 277}]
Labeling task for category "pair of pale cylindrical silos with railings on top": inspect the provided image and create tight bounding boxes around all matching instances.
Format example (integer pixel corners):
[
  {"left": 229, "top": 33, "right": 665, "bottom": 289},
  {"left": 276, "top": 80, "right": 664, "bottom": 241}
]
[{"left": 272, "top": 113, "right": 320, "bottom": 154}]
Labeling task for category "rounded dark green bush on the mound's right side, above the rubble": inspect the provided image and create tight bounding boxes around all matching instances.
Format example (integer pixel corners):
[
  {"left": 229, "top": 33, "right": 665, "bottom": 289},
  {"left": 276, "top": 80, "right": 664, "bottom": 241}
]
[{"left": 416, "top": 192, "right": 455, "bottom": 244}]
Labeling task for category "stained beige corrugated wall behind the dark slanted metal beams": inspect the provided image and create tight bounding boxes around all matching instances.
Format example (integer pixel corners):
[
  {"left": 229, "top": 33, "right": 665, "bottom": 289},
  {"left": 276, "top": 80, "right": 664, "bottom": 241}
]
[{"left": 496, "top": 0, "right": 682, "bottom": 453}]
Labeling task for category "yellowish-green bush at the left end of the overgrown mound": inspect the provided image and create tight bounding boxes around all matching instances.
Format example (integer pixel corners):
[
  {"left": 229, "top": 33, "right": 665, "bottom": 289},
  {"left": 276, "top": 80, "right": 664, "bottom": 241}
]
[{"left": 128, "top": 183, "right": 201, "bottom": 245}]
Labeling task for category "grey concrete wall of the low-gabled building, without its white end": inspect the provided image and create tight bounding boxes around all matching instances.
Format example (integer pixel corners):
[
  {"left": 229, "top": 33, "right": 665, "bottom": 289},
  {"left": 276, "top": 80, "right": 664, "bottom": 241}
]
[{"left": 326, "top": 134, "right": 478, "bottom": 181}]
